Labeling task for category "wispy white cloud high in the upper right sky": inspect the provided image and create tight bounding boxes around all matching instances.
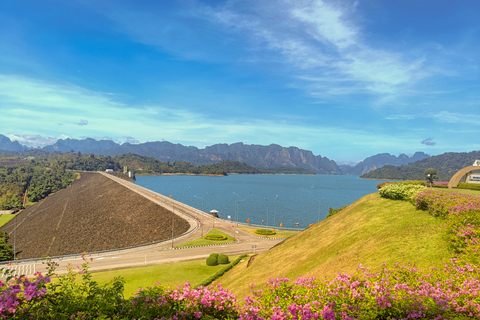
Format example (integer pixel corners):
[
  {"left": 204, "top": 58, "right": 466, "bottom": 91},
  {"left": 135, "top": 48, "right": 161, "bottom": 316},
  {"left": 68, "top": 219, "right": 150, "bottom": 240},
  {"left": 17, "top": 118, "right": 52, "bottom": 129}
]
[{"left": 199, "top": 1, "right": 426, "bottom": 96}]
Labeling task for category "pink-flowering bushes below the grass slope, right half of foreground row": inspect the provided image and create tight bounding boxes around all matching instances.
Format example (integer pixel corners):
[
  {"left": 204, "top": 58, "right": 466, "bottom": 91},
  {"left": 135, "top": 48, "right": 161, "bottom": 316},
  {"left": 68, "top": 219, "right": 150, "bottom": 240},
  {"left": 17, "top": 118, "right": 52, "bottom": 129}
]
[{"left": 240, "top": 260, "right": 480, "bottom": 320}]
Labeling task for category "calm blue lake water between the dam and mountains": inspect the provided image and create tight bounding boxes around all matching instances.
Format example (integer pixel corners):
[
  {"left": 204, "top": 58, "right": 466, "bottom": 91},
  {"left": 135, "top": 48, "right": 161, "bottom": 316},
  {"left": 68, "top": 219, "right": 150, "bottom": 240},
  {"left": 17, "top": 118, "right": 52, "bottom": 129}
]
[{"left": 136, "top": 175, "right": 381, "bottom": 229}]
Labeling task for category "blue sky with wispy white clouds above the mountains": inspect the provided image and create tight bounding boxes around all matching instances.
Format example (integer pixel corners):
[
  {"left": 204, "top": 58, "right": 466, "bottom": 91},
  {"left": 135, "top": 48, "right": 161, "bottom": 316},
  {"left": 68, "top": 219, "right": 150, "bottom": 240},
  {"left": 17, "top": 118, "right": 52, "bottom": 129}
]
[{"left": 0, "top": 0, "right": 480, "bottom": 162}]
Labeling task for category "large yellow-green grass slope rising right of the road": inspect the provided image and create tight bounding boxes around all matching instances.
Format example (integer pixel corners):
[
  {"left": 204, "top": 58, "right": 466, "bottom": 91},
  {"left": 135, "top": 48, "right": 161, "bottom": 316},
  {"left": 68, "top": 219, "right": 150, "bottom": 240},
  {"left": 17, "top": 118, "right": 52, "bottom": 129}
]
[{"left": 219, "top": 194, "right": 451, "bottom": 297}]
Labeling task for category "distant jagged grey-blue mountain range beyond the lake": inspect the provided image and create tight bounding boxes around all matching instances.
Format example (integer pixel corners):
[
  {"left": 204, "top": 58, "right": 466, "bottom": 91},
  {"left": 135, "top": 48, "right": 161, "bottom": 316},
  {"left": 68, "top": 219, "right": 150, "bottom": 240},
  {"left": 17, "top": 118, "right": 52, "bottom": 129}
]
[{"left": 0, "top": 134, "right": 429, "bottom": 175}]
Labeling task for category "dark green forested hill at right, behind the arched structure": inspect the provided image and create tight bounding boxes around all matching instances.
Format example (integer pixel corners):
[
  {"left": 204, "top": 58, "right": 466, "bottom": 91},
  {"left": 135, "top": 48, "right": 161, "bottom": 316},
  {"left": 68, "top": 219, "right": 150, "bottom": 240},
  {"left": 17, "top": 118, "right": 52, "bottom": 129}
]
[{"left": 360, "top": 151, "right": 480, "bottom": 181}]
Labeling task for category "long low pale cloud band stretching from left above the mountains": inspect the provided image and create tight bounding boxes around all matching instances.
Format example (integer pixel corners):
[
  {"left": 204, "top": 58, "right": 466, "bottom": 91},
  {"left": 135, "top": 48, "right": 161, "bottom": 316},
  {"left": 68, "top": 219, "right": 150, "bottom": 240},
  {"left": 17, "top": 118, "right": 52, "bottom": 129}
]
[{"left": 0, "top": 75, "right": 412, "bottom": 158}]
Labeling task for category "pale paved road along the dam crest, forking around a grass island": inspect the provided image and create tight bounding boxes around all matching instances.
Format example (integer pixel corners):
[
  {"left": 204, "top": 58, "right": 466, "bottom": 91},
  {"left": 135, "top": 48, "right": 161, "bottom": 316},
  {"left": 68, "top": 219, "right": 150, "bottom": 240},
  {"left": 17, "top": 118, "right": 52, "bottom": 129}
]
[{"left": 0, "top": 173, "right": 282, "bottom": 275}]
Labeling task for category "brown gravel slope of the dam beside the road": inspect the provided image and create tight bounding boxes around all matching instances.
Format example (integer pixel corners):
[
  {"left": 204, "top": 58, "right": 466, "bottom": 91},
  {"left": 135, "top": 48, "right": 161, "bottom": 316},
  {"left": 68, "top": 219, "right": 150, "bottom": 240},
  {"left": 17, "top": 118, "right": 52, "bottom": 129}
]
[{"left": 1, "top": 173, "right": 189, "bottom": 259}]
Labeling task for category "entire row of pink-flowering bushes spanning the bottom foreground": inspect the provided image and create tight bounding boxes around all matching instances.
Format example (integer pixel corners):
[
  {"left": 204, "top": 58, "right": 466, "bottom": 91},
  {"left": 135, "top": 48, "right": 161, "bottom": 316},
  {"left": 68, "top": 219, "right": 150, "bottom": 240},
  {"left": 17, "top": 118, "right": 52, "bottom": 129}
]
[{"left": 0, "top": 255, "right": 480, "bottom": 320}]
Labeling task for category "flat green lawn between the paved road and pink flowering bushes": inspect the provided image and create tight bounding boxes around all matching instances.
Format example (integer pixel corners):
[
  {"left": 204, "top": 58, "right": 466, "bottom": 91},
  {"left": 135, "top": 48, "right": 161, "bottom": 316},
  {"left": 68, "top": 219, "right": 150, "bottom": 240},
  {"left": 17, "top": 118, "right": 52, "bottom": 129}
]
[{"left": 92, "top": 256, "right": 237, "bottom": 297}]
